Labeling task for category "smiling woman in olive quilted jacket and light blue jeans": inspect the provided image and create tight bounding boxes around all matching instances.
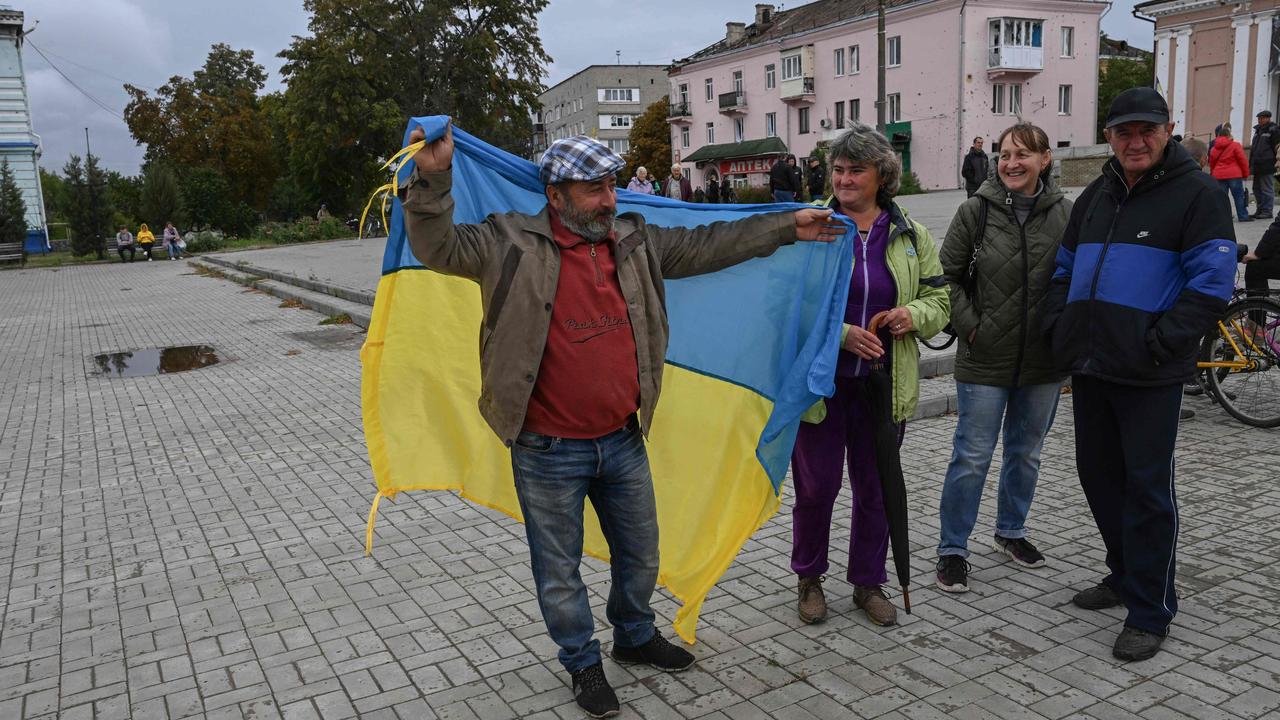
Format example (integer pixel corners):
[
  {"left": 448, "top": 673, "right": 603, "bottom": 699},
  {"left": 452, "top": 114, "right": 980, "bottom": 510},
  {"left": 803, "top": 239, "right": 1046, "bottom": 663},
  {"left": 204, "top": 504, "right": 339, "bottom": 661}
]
[{"left": 937, "top": 123, "right": 1071, "bottom": 592}]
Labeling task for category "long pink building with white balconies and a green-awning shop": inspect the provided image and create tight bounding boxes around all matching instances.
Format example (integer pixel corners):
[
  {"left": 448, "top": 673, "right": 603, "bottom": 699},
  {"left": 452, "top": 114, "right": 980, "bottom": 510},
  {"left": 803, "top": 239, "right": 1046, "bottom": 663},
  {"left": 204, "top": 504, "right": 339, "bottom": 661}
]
[{"left": 668, "top": 0, "right": 1107, "bottom": 188}]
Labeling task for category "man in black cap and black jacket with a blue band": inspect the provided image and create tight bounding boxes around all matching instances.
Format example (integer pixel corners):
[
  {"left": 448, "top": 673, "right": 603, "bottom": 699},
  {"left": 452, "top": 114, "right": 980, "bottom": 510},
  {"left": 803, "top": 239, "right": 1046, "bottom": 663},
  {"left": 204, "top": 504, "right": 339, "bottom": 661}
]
[{"left": 1044, "top": 87, "right": 1235, "bottom": 660}]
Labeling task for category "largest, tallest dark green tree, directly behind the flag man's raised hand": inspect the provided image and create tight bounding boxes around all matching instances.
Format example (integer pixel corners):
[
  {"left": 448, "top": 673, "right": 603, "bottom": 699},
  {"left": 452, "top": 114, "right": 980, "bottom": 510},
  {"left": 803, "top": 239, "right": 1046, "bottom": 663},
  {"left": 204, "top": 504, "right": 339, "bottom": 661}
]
[{"left": 280, "top": 0, "right": 550, "bottom": 213}]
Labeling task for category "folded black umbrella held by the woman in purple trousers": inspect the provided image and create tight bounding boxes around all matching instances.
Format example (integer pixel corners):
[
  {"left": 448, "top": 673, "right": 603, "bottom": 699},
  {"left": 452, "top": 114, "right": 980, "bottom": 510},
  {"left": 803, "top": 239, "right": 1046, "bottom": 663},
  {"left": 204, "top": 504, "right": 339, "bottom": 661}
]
[{"left": 865, "top": 313, "right": 911, "bottom": 615}]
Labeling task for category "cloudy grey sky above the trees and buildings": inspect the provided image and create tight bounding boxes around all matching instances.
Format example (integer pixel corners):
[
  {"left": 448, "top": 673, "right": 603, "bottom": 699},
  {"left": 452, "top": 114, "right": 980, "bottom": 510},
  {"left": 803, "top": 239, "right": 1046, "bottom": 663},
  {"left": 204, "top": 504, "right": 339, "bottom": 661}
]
[{"left": 15, "top": 0, "right": 1152, "bottom": 174}]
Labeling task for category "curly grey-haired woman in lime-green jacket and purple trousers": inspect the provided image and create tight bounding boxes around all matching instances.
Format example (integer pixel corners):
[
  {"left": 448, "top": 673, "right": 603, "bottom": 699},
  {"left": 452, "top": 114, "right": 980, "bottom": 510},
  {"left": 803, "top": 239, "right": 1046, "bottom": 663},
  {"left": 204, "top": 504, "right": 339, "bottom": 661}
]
[{"left": 791, "top": 123, "right": 950, "bottom": 625}]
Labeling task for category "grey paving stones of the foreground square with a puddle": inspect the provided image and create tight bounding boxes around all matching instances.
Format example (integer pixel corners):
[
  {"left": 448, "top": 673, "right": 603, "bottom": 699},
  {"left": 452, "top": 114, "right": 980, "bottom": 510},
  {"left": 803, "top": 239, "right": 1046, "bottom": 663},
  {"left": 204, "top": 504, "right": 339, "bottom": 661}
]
[{"left": 0, "top": 252, "right": 1280, "bottom": 720}]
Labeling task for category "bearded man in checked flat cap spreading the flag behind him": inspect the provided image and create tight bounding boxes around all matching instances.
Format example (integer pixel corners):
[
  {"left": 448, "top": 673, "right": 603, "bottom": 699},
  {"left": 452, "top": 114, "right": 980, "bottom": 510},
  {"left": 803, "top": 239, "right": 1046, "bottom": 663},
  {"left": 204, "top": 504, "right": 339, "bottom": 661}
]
[{"left": 402, "top": 129, "right": 846, "bottom": 717}]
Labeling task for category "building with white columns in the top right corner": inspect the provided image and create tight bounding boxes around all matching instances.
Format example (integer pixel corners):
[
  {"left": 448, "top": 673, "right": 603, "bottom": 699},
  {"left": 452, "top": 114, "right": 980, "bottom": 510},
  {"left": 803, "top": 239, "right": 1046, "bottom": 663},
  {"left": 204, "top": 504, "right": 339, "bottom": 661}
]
[{"left": 1134, "top": 0, "right": 1280, "bottom": 143}]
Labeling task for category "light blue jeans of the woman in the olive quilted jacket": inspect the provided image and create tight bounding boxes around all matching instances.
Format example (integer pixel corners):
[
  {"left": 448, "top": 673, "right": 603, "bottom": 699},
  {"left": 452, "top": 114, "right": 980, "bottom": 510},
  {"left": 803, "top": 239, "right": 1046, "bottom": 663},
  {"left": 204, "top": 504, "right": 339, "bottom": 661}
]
[{"left": 938, "top": 382, "right": 1061, "bottom": 557}]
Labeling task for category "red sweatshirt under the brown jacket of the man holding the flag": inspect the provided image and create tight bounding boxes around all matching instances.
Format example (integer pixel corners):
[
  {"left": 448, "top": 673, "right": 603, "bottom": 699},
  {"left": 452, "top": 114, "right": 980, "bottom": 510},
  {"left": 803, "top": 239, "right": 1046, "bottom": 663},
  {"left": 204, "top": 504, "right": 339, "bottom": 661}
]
[{"left": 525, "top": 208, "right": 640, "bottom": 438}]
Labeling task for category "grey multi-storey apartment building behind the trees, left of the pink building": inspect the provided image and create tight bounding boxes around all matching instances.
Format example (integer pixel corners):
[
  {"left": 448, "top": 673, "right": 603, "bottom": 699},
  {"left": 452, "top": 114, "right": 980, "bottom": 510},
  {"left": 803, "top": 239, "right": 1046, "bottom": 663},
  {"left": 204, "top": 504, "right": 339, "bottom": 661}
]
[{"left": 532, "top": 64, "right": 667, "bottom": 160}]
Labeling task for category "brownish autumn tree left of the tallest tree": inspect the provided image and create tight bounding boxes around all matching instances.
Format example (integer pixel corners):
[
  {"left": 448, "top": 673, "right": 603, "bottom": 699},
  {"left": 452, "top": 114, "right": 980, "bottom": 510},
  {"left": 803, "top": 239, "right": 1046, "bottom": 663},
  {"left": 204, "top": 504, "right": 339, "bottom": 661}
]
[{"left": 124, "top": 44, "right": 279, "bottom": 209}]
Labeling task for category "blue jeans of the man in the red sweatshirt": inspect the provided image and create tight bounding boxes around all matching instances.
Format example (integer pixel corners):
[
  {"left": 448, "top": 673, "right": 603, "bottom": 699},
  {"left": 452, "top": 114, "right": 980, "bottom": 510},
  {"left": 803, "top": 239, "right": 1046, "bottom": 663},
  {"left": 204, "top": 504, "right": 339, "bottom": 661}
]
[{"left": 511, "top": 419, "right": 658, "bottom": 673}]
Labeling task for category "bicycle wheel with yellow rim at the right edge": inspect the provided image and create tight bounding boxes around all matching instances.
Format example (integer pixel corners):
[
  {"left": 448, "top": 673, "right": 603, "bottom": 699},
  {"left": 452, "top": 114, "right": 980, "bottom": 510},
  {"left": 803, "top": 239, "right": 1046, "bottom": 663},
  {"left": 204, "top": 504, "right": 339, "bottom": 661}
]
[{"left": 1204, "top": 299, "right": 1280, "bottom": 428}]
